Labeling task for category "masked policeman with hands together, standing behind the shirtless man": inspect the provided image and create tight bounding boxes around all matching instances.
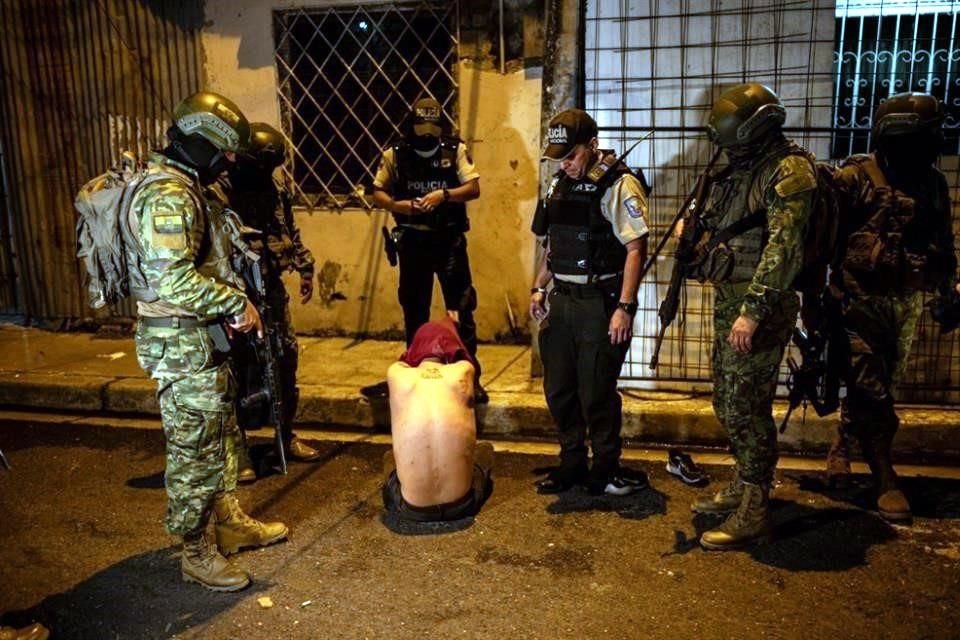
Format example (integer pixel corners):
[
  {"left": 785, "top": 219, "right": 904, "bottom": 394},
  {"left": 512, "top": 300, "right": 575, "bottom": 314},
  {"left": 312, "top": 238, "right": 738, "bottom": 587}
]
[{"left": 373, "top": 98, "right": 487, "bottom": 402}]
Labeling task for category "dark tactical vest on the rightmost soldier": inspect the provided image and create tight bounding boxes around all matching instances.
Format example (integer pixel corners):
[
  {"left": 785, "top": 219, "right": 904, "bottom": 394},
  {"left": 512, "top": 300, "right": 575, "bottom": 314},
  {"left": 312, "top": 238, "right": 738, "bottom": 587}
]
[{"left": 841, "top": 154, "right": 956, "bottom": 295}]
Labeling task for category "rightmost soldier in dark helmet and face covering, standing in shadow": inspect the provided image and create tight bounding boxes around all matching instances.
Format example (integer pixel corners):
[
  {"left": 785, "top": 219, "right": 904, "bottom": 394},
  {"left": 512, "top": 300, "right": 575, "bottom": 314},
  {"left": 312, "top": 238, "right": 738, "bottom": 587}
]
[{"left": 828, "top": 93, "right": 957, "bottom": 522}]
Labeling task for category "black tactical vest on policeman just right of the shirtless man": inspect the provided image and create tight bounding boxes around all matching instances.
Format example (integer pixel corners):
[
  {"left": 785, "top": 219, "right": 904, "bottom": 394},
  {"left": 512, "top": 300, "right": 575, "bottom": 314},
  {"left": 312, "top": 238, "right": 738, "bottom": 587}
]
[{"left": 543, "top": 165, "right": 630, "bottom": 277}]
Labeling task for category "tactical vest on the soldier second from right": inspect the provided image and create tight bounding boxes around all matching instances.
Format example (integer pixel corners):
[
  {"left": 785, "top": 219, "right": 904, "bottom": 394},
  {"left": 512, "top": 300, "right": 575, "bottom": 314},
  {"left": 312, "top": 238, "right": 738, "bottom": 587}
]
[{"left": 687, "top": 142, "right": 814, "bottom": 284}]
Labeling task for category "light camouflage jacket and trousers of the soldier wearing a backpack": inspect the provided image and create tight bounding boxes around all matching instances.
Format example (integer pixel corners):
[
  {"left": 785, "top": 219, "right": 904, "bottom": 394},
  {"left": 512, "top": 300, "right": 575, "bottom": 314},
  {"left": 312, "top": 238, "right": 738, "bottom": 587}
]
[{"left": 130, "top": 155, "right": 246, "bottom": 536}]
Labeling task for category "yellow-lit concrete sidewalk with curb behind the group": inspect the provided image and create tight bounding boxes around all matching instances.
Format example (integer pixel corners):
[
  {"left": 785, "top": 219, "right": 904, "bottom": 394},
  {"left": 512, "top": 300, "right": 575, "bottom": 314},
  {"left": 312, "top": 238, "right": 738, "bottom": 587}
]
[{"left": 0, "top": 325, "right": 960, "bottom": 460}]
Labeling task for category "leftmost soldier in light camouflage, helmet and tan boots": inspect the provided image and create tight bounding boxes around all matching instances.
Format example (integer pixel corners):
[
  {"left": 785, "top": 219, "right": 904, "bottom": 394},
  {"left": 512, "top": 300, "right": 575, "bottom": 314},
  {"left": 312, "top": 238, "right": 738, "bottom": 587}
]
[{"left": 127, "top": 92, "right": 287, "bottom": 591}]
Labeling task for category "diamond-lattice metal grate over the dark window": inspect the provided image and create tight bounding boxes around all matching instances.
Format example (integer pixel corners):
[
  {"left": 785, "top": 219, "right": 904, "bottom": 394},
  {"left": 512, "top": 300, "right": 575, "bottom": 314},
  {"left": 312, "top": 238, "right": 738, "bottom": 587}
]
[{"left": 273, "top": 2, "right": 458, "bottom": 209}]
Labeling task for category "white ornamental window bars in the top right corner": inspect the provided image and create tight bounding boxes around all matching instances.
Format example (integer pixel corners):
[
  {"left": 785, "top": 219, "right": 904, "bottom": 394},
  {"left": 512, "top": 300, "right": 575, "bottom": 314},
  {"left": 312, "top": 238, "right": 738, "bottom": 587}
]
[{"left": 831, "top": 0, "right": 960, "bottom": 158}]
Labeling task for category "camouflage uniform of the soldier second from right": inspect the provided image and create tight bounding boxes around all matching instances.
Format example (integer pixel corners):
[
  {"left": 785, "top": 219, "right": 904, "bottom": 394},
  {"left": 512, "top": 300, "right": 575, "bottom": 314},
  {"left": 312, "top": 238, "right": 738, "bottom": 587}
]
[{"left": 693, "top": 139, "right": 817, "bottom": 486}]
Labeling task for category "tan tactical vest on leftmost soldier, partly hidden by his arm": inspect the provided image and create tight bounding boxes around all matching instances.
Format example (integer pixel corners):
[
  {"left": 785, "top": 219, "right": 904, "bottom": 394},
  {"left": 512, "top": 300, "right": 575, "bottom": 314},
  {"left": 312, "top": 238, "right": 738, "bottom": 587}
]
[{"left": 135, "top": 160, "right": 245, "bottom": 317}]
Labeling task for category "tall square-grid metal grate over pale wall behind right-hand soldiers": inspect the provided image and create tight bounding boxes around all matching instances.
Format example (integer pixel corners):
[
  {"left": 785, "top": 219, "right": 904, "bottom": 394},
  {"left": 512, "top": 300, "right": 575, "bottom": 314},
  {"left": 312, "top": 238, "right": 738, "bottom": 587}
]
[{"left": 585, "top": 0, "right": 960, "bottom": 402}]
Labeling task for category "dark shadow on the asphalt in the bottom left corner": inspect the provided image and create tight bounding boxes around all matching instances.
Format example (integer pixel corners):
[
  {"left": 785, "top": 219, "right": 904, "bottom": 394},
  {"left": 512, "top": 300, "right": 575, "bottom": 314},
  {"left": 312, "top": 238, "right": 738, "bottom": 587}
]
[{"left": 0, "top": 547, "right": 271, "bottom": 640}]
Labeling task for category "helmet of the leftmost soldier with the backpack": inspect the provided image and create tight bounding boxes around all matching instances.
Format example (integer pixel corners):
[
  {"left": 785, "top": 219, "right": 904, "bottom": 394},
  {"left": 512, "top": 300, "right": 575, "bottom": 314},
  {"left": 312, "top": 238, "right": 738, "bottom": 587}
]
[{"left": 173, "top": 91, "right": 250, "bottom": 152}]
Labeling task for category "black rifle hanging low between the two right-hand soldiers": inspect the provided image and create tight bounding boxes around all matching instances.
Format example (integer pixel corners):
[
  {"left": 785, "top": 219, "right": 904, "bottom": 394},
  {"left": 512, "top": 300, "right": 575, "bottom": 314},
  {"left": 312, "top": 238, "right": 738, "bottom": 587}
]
[{"left": 780, "top": 327, "right": 840, "bottom": 433}]
